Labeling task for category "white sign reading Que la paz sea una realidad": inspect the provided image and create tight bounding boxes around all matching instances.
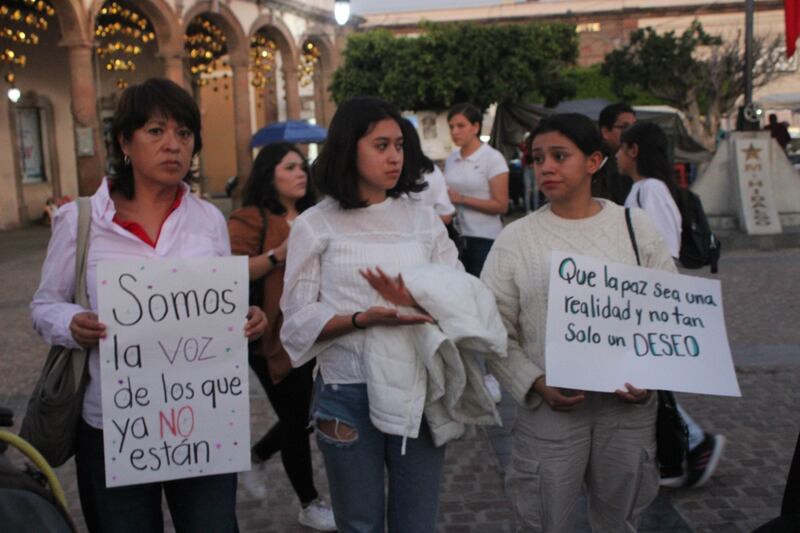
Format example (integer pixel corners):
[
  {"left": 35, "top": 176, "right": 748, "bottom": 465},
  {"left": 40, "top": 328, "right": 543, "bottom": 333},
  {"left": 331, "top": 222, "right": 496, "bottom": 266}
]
[{"left": 545, "top": 252, "right": 741, "bottom": 396}]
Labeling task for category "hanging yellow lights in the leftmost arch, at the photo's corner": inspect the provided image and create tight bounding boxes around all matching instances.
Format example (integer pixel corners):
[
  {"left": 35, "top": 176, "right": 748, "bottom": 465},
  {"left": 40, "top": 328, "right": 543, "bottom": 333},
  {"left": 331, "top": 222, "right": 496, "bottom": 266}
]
[{"left": 0, "top": 0, "right": 56, "bottom": 101}]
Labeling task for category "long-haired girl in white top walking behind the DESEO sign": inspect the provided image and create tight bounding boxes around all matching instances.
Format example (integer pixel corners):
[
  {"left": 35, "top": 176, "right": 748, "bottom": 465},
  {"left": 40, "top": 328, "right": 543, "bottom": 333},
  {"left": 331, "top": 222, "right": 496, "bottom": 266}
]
[{"left": 617, "top": 122, "right": 725, "bottom": 488}]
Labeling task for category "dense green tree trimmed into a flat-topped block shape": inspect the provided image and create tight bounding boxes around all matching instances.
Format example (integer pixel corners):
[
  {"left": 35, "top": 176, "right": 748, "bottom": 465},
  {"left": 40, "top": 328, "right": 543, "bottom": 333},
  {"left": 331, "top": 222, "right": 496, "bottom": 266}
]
[{"left": 331, "top": 23, "right": 578, "bottom": 110}]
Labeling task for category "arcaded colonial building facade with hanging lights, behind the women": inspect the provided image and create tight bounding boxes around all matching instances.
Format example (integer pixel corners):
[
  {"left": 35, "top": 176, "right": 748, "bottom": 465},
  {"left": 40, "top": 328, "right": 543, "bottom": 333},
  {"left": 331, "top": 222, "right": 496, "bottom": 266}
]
[{"left": 0, "top": 0, "right": 341, "bottom": 229}]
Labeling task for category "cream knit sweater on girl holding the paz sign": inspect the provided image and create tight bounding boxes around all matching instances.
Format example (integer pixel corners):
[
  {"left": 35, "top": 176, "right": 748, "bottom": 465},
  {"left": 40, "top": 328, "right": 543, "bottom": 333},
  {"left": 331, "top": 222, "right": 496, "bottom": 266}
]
[{"left": 481, "top": 200, "right": 675, "bottom": 408}]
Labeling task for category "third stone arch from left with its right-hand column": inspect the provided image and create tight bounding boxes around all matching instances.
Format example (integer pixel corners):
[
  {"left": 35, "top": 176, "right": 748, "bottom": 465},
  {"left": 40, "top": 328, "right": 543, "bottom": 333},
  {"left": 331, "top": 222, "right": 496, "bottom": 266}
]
[{"left": 181, "top": 0, "right": 252, "bottom": 189}]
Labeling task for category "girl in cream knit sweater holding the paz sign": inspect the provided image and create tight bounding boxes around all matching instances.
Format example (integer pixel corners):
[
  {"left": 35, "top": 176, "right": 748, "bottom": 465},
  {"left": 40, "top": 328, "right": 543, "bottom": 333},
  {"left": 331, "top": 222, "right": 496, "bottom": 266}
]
[{"left": 481, "top": 114, "right": 675, "bottom": 533}]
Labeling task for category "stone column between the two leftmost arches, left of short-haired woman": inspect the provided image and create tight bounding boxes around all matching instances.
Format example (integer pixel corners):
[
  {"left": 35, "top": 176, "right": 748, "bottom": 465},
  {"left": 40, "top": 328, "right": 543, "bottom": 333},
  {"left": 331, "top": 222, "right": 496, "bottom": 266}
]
[{"left": 65, "top": 42, "right": 105, "bottom": 196}]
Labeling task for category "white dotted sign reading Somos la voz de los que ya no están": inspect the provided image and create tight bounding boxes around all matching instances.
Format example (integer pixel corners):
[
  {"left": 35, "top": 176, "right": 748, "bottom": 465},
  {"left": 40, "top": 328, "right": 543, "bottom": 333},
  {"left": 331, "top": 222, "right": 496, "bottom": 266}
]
[{"left": 97, "top": 257, "right": 250, "bottom": 487}]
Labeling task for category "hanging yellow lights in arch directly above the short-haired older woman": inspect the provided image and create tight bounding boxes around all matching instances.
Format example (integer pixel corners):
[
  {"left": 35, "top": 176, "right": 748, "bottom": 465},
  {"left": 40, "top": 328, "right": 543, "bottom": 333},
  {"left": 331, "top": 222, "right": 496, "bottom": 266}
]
[{"left": 94, "top": 0, "right": 156, "bottom": 89}]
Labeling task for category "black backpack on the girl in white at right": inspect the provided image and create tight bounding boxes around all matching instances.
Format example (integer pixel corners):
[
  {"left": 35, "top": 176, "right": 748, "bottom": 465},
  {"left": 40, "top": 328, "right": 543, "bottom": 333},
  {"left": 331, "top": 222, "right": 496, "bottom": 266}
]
[{"left": 675, "top": 188, "right": 721, "bottom": 274}]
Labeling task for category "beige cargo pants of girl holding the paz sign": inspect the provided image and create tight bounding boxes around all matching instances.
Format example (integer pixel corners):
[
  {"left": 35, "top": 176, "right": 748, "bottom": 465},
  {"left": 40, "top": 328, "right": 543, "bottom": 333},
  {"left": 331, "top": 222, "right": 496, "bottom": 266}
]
[{"left": 506, "top": 392, "right": 658, "bottom": 533}]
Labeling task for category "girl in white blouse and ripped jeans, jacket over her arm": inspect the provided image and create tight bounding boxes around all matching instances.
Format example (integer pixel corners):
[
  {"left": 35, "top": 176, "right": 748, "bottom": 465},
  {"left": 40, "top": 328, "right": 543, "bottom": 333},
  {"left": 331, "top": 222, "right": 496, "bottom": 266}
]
[{"left": 281, "top": 98, "right": 460, "bottom": 533}]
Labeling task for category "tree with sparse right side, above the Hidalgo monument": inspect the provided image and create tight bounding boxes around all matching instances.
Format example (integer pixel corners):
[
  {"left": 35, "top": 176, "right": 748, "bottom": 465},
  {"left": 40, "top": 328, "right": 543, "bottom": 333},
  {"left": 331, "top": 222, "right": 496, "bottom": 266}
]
[{"left": 602, "top": 21, "right": 782, "bottom": 146}]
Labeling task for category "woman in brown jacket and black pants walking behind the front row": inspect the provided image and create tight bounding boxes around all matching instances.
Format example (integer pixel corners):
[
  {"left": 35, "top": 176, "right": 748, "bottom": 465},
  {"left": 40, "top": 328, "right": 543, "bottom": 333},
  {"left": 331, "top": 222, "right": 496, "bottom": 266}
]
[{"left": 228, "top": 142, "right": 336, "bottom": 531}]
